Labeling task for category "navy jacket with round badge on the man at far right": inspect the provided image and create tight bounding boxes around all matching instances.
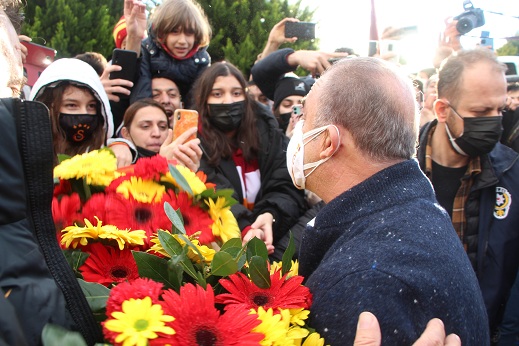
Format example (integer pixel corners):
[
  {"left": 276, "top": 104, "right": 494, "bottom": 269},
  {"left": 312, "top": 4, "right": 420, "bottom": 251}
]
[{"left": 418, "top": 120, "right": 519, "bottom": 331}]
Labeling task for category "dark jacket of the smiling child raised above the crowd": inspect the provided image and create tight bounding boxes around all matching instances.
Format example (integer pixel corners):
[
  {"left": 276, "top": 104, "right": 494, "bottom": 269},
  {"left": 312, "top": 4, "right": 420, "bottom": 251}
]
[{"left": 130, "top": 36, "right": 211, "bottom": 104}]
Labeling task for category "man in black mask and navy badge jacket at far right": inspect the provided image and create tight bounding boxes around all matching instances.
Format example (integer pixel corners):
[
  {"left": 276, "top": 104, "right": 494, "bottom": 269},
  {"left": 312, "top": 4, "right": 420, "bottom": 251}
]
[{"left": 418, "top": 48, "right": 519, "bottom": 344}]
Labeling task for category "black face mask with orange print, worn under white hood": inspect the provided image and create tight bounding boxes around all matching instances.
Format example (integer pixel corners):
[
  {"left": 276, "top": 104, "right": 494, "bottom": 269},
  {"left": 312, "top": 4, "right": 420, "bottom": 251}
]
[{"left": 59, "top": 113, "right": 102, "bottom": 144}]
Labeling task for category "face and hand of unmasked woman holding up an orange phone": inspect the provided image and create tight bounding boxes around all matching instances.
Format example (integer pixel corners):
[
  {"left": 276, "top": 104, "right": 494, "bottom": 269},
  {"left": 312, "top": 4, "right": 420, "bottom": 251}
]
[{"left": 121, "top": 99, "right": 202, "bottom": 172}]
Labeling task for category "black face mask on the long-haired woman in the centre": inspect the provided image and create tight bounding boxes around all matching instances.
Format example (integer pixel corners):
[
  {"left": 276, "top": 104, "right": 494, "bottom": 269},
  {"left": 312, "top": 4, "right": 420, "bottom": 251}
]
[{"left": 208, "top": 101, "right": 245, "bottom": 132}]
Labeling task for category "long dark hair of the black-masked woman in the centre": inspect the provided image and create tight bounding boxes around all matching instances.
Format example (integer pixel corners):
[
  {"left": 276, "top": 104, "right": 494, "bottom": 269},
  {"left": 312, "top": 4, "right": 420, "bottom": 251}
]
[{"left": 193, "top": 62, "right": 259, "bottom": 166}]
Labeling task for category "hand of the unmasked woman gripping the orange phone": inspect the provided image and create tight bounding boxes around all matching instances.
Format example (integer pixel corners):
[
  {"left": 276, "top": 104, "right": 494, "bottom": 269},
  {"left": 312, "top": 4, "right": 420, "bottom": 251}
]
[{"left": 159, "top": 127, "right": 202, "bottom": 172}]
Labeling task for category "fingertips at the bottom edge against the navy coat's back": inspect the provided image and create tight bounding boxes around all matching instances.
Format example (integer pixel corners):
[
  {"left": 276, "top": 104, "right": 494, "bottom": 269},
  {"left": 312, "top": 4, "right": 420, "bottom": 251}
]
[{"left": 353, "top": 312, "right": 461, "bottom": 346}]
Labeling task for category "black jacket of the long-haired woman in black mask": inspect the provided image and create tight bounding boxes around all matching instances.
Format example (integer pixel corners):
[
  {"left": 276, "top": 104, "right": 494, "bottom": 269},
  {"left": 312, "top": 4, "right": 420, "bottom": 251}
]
[{"left": 200, "top": 106, "right": 305, "bottom": 243}]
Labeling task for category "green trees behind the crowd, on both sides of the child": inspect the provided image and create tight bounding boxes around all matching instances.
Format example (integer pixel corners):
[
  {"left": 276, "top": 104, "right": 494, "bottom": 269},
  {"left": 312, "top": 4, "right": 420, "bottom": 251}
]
[{"left": 22, "top": 0, "right": 317, "bottom": 77}]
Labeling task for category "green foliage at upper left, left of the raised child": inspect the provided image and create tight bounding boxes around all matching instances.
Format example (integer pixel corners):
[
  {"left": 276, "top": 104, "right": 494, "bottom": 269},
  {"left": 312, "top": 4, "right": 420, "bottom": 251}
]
[{"left": 22, "top": 0, "right": 124, "bottom": 58}]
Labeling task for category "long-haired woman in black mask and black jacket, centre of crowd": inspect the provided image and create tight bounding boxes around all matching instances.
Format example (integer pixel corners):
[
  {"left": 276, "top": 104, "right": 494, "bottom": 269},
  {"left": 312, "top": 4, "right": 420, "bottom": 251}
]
[{"left": 193, "top": 63, "right": 304, "bottom": 253}]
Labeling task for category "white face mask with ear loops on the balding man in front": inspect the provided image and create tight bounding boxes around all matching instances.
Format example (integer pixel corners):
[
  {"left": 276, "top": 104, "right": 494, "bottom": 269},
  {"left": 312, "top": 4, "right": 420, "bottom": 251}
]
[{"left": 287, "top": 120, "right": 340, "bottom": 190}]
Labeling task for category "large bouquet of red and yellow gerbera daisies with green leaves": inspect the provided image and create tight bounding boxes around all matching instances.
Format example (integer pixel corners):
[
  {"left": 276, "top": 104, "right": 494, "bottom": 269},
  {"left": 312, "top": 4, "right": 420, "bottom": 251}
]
[{"left": 46, "top": 149, "right": 324, "bottom": 346}]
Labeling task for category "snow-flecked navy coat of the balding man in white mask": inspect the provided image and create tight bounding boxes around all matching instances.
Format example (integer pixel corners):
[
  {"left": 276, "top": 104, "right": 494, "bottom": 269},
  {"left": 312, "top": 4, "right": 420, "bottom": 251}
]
[{"left": 299, "top": 160, "right": 490, "bottom": 346}]
